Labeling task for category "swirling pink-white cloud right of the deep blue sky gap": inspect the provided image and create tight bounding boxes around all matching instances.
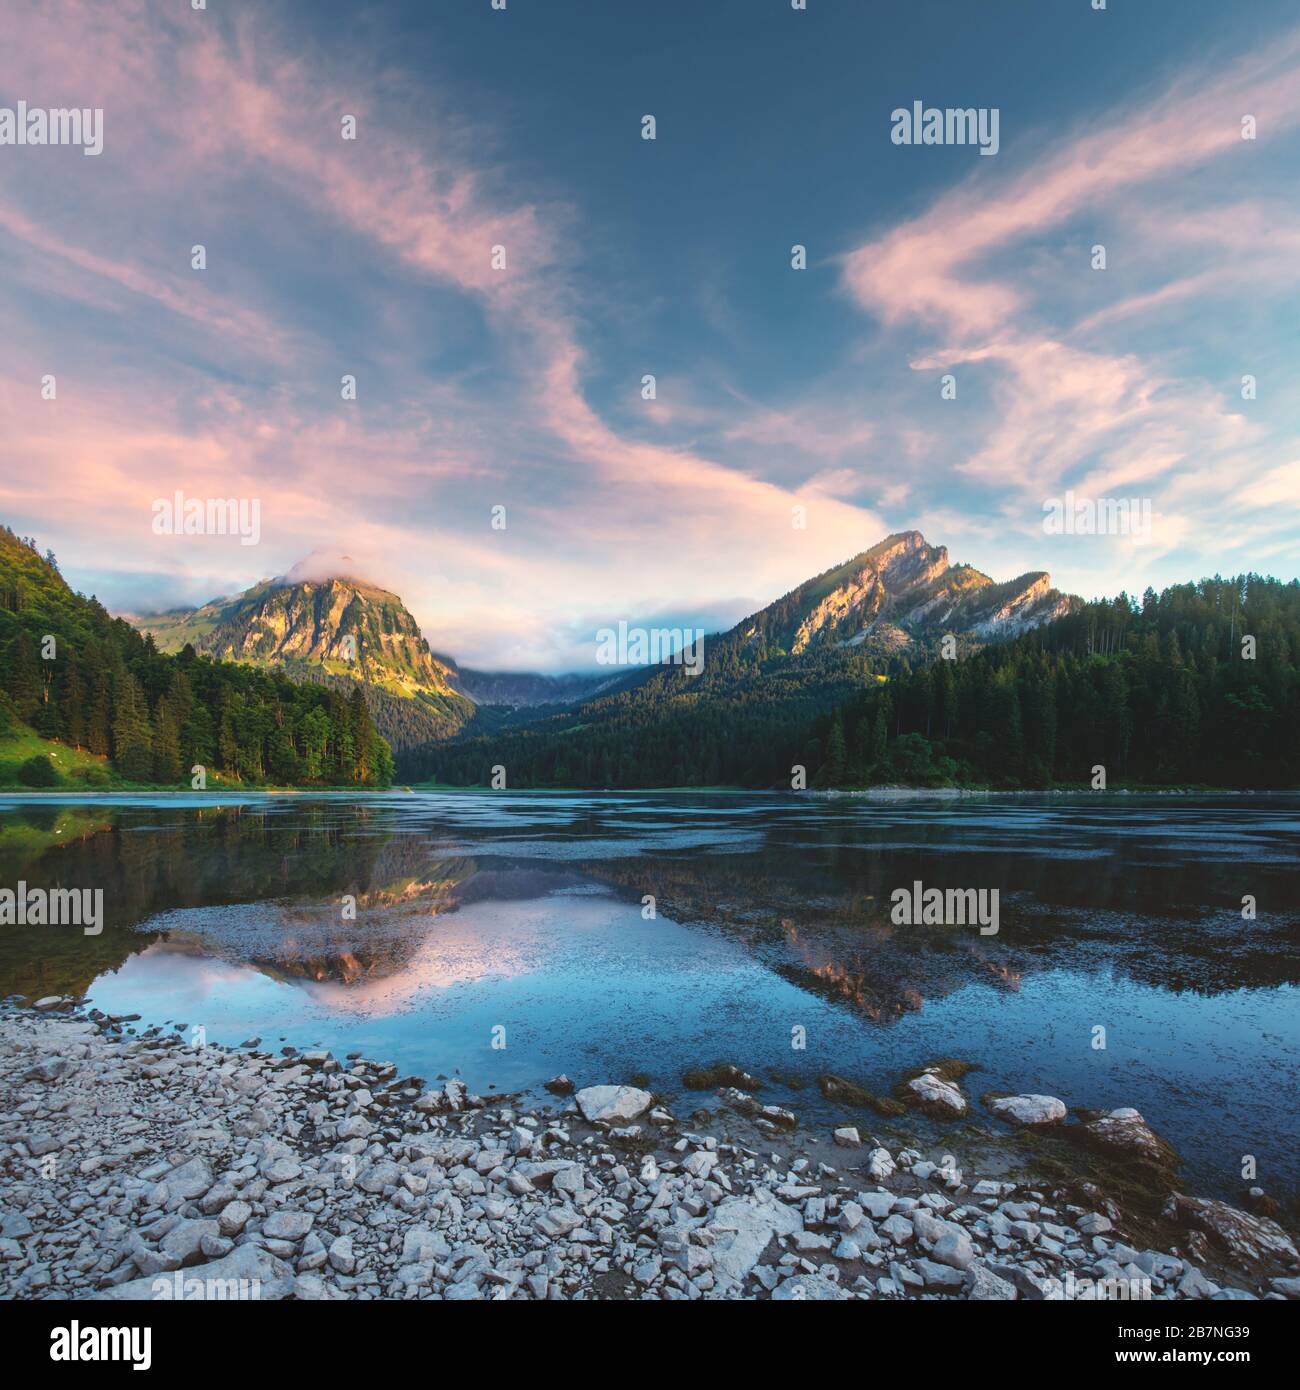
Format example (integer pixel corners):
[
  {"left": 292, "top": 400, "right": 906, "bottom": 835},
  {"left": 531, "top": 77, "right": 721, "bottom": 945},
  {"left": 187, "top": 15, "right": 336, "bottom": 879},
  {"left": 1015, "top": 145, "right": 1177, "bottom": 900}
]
[{"left": 843, "top": 31, "right": 1300, "bottom": 573}]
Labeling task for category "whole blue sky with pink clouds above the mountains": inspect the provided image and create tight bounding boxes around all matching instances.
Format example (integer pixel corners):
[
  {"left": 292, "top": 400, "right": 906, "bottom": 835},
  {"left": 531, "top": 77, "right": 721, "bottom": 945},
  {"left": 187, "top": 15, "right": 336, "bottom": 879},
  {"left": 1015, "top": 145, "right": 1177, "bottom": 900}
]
[{"left": 0, "top": 0, "right": 1300, "bottom": 671}]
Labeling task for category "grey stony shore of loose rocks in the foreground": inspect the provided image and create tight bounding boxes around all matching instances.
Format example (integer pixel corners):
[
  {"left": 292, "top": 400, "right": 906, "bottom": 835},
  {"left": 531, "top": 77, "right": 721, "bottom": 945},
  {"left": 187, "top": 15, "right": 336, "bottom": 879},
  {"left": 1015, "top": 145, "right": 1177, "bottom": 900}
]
[{"left": 0, "top": 999, "right": 1300, "bottom": 1301}]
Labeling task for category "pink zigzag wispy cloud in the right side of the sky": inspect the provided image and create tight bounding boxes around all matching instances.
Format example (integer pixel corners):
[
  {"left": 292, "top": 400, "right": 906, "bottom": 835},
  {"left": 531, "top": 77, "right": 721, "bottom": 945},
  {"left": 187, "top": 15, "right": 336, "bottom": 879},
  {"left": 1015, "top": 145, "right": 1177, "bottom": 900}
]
[{"left": 844, "top": 31, "right": 1300, "bottom": 553}]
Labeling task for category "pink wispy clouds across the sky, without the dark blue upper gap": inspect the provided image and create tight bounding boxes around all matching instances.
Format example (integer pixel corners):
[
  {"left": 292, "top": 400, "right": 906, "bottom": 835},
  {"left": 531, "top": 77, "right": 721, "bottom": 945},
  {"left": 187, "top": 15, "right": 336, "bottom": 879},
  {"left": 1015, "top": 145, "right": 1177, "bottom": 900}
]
[{"left": 0, "top": 0, "right": 1300, "bottom": 667}]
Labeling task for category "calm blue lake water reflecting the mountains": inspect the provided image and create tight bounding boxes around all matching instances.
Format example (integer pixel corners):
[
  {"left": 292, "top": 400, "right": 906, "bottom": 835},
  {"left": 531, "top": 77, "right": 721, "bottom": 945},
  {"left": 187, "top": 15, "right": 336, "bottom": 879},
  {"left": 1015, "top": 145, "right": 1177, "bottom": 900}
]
[{"left": 0, "top": 792, "right": 1300, "bottom": 1200}]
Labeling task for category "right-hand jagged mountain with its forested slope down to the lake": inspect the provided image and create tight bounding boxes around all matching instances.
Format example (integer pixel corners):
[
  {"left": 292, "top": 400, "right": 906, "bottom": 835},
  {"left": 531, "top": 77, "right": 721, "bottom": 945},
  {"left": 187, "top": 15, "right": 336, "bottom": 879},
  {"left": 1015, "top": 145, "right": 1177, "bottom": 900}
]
[{"left": 403, "top": 531, "right": 1079, "bottom": 787}]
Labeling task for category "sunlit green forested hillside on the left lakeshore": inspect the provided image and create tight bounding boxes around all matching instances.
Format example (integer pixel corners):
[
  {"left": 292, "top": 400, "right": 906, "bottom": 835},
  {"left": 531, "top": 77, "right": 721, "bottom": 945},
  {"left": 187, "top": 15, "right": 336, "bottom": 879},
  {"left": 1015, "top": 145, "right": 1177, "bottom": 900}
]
[{"left": 0, "top": 527, "right": 392, "bottom": 787}]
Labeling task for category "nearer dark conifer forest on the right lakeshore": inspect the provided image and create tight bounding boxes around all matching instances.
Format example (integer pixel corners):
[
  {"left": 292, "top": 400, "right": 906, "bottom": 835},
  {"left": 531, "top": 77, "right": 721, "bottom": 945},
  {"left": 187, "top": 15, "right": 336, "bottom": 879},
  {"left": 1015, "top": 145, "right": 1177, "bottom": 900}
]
[{"left": 805, "top": 575, "right": 1300, "bottom": 787}]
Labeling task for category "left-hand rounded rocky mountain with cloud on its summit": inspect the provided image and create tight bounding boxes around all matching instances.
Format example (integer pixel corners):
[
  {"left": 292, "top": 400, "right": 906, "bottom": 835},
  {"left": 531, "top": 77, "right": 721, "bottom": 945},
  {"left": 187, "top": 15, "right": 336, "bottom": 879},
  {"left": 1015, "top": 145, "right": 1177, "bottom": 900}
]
[{"left": 132, "top": 556, "right": 476, "bottom": 752}]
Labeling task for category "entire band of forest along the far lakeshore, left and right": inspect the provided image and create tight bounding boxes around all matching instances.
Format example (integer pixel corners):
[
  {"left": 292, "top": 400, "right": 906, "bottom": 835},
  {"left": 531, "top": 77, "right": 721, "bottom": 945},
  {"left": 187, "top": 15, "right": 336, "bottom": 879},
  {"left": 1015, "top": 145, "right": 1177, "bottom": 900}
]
[{"left": 0, "top": 527, "right": 1300, "bottom": 798}]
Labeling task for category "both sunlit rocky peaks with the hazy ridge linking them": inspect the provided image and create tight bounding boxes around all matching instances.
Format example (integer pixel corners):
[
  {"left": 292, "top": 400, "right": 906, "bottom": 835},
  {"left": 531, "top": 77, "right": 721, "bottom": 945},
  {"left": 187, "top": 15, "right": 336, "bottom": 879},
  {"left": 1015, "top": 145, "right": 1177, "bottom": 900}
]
[{"left": 133, "top": 530, "right": 1079, "bottom": 759}]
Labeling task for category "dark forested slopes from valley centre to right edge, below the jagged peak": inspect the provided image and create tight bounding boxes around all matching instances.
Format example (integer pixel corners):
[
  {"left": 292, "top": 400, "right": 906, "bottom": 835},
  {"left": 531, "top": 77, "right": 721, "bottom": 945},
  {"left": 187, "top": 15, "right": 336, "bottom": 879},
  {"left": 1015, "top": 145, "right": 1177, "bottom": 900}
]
[{"left": 413, "top": 575, "right": 1300, "bottom": 787}]
